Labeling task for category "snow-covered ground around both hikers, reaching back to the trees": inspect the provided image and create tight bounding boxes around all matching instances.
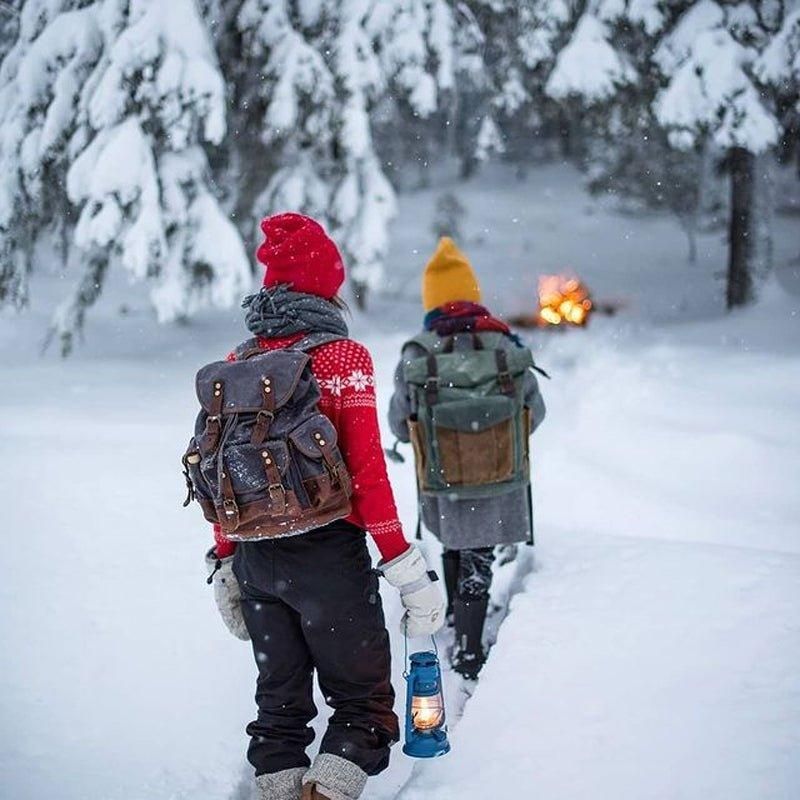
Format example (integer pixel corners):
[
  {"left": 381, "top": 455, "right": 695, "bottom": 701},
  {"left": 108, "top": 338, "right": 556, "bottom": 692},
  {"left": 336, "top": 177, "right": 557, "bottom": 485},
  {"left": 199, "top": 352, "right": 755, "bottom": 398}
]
[{"left": 0, "top": 162, "right": 800, "bottom": 800}]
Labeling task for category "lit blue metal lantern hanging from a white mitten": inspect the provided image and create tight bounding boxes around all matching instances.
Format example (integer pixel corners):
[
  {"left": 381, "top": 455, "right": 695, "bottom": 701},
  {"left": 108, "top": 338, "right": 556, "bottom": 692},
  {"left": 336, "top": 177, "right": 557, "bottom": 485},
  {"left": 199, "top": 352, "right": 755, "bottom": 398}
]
[{"left": 403, "top": 642, "right": 450, "bottom": 758}]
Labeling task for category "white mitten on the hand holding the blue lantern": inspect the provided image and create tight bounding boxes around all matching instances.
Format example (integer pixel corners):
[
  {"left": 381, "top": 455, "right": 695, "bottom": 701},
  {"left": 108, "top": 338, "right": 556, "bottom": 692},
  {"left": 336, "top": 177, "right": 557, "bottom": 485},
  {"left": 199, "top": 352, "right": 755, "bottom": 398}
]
[{"left": 378, "top": 544, "right": 445, "bottom": 637}]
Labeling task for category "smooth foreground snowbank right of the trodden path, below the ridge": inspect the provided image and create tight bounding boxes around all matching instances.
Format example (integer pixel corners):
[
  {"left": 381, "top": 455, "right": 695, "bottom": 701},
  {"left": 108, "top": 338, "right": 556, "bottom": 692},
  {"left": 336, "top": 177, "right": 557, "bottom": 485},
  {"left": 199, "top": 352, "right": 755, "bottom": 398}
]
[{"left": 399, "top": 531, "right": 800, "bottom": 800}]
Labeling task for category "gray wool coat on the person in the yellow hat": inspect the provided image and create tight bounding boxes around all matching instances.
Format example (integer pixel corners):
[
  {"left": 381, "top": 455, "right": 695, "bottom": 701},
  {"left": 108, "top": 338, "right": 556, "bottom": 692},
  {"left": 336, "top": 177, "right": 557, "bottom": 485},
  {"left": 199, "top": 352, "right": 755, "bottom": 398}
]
[{"left": 389, "top": 336, "right": 545, "bottom": 550}]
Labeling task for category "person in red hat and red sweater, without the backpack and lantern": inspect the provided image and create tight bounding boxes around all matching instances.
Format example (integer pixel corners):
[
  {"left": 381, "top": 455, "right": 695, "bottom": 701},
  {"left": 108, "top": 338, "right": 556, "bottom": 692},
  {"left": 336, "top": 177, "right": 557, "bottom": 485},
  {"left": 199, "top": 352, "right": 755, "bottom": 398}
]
[{"left": 207, "top": 214, "right": 444, "bottom": 800}]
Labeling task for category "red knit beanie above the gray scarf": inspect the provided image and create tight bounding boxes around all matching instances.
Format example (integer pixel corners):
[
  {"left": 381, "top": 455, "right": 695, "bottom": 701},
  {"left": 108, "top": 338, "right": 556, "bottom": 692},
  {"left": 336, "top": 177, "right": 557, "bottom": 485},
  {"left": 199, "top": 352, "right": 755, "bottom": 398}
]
[{"left": 256, "top": 213, "right": 344, "bottom": 300}]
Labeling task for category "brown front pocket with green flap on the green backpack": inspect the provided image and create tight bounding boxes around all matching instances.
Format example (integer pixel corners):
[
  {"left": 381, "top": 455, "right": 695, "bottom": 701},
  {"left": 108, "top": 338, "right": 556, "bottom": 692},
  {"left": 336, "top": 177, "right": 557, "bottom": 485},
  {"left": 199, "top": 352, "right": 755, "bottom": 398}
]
[{"left": 433, "top": 397, "right": 516, "bottom": 486}]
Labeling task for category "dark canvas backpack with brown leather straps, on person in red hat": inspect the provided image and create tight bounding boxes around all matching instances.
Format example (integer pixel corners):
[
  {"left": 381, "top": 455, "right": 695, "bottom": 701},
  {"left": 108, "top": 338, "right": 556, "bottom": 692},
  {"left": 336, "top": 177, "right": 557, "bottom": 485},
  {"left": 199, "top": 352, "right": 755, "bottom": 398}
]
[{"left": 183, "top": 334, "right": 352, "bottom": 541}]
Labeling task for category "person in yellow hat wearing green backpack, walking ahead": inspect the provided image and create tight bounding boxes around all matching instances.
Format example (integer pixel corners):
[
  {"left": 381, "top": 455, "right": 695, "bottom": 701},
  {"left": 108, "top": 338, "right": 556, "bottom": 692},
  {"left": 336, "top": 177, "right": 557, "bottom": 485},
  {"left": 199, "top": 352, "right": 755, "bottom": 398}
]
[{"left": 389, "top": 237, "right": 545, "bottom": 679}]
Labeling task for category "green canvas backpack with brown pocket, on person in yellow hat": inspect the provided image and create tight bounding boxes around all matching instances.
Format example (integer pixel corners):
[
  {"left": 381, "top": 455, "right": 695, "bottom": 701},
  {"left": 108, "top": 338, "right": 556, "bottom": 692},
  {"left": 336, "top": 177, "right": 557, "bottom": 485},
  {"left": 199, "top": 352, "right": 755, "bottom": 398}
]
[{"left": 403, "top": 333, "right": 534, "bottom": 499}]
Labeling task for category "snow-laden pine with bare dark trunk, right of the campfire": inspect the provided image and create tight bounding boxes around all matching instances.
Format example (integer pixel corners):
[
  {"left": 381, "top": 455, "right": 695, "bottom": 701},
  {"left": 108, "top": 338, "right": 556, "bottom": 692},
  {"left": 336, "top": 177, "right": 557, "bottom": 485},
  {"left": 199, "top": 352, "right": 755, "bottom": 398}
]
[{"left": 654, "top": 0, "right": 779, "bottom": 308}]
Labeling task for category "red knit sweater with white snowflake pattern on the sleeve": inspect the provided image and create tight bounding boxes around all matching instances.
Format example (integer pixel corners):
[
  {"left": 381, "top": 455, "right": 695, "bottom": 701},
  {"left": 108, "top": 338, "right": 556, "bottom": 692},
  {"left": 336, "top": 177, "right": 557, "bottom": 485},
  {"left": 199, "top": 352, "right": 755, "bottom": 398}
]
[{"left": 214, "top": 334, "right": 408, "bottom": 561}]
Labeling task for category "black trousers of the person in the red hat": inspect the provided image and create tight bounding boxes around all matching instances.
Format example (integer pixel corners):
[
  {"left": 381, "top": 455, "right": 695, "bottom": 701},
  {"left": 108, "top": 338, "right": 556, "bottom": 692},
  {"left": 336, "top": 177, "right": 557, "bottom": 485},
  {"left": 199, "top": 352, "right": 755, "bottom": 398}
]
[{"left": 233, "top": 521, "right": 399, "bottom": 775}]
